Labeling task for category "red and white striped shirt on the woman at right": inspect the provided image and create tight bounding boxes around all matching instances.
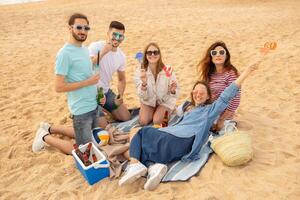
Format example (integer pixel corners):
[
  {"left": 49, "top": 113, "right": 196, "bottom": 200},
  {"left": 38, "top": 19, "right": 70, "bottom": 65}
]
[{"left": 209, "top": 70, "right": 241, "bottom": 117}]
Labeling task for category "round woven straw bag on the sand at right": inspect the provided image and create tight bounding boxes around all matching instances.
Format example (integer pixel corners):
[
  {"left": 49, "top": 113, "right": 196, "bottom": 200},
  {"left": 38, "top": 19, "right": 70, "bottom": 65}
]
[{"left": 211, "top": 127, "right": 253, "bottom": 166}]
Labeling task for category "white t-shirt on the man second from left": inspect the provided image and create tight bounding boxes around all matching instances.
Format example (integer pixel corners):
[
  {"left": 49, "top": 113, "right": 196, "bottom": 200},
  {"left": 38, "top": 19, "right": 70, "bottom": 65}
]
[{"left": 89, "top": 41, "right": 126, "bottom": 93}]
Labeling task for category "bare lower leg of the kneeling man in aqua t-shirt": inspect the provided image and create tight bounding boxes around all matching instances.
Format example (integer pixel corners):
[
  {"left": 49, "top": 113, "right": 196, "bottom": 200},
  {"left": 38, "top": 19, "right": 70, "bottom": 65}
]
[{"left": 44, "top": 135, "right": 73, "bottom": 155}]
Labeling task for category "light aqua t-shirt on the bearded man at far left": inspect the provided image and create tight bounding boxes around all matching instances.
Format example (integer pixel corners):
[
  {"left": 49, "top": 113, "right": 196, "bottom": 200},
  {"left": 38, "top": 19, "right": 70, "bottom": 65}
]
[{"left": 55, "top": 44, "right": 97, "bottom": 115}]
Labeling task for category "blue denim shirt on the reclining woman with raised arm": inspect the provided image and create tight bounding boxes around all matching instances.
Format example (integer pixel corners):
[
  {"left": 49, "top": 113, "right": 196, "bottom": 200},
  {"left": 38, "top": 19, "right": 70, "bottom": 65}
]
[{"left": 159, "top": 82, "right": 239, "bottom": 161}]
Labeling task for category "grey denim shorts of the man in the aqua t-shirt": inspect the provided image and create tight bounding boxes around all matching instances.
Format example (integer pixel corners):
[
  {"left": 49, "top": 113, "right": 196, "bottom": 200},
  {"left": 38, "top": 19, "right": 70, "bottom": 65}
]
[{"left": 73, "top": 108, "right": 99, "bottom": 145}]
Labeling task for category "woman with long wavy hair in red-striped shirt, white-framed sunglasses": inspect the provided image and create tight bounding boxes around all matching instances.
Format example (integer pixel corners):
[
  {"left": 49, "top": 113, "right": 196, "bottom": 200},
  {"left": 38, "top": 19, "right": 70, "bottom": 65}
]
[{"left": 198, "top": 41, "right": 240, "bottom": 131}]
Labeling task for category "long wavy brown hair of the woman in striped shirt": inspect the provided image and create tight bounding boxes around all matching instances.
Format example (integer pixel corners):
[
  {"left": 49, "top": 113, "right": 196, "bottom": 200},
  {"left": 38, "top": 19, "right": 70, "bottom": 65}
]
[{"left": 197, "top": 41, "right": 238, "bottom": 83}]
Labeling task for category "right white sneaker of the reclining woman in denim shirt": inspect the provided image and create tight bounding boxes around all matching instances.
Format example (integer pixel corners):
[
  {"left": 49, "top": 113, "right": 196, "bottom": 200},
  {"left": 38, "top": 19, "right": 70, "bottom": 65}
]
[{"left": 144, "top": 163, "right": 168, "bottom": 190}]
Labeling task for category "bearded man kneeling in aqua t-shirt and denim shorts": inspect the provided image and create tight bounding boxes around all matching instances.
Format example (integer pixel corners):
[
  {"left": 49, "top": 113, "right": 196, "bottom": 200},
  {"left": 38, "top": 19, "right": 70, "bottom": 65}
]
[{"left": 32, "top": 13, "right": 100, "bottom": 153}]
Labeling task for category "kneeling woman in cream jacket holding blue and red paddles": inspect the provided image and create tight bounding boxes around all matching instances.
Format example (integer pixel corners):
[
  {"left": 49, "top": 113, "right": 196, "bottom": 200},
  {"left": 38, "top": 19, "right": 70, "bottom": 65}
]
[{"left": 135, "top": 43, "right": 179, "bottom": 125}]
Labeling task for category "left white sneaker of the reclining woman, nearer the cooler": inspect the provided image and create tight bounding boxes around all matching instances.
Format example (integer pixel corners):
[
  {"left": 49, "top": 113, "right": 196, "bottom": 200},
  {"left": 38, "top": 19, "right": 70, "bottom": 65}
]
[{"left": 119, "top": 163, "right": 147, "bottom": 186}]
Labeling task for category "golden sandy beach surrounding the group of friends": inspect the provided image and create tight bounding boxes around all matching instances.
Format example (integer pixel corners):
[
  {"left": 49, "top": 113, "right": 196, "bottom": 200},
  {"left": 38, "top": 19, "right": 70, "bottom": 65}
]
[{"left": 0, "top": 0, "right": 300, "bottom": 200}]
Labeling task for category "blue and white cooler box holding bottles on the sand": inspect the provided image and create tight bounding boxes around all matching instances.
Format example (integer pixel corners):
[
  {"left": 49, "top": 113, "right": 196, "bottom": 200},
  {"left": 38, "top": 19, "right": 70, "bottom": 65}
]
[{"left": 72, "top": 143, "right": 109, "bottom": 185}]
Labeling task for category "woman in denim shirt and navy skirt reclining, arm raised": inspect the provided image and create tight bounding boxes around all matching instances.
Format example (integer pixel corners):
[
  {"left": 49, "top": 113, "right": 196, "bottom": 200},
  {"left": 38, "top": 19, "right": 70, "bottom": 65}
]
[{"left": 119, "top": 62, "right": 259, "bottom": 190}]
